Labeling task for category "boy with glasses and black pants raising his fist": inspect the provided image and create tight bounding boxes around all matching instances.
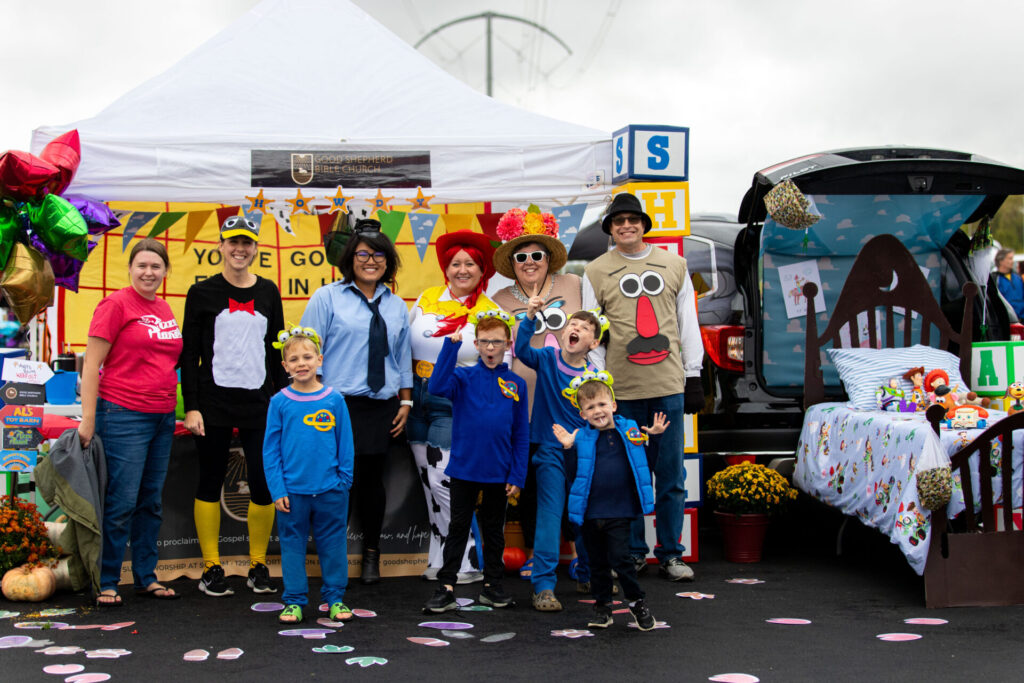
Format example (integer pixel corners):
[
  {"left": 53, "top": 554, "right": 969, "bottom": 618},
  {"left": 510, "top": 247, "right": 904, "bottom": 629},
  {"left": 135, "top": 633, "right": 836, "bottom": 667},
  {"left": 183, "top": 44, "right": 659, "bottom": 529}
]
[{"left": 423, "top": 311, "right": 529, "bottom": 613}]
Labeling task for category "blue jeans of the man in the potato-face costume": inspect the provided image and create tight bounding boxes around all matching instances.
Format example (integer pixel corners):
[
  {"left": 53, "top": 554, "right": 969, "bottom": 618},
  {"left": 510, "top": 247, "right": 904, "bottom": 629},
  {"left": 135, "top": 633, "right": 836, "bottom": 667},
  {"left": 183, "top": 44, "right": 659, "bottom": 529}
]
[{"left": 618, "top": 393, "right": 686, "bottom": 562}]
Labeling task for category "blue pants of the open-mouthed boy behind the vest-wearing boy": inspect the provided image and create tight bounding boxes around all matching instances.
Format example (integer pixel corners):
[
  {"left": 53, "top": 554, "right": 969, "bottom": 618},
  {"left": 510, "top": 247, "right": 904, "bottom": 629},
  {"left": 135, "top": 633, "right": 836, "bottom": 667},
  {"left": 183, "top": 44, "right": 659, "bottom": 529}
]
[{"left": 530, "top": 443, "right": 590, "bottom": 593}]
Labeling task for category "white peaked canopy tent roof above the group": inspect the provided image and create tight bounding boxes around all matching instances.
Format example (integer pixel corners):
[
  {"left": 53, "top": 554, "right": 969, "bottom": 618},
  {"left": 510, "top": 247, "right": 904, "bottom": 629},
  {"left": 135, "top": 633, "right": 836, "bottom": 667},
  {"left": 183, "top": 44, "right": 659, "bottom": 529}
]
[{"left": 32, "top": 0, "right": 611, "bottom": 203}]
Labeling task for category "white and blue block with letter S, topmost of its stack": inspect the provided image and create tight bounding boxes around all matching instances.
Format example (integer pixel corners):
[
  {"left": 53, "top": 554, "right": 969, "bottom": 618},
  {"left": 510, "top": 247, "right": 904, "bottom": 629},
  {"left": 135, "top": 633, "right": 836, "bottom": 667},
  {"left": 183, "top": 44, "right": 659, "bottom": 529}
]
[{"left": 611, "top": 125, "right": 690, "bottom": 184}]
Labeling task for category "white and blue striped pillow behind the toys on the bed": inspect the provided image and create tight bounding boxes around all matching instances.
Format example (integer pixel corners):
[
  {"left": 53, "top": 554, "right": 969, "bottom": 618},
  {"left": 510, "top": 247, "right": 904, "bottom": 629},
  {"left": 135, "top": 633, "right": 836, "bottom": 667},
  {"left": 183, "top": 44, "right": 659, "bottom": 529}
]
[{"left": 828, "top": 344, "right": 969, "bottom": 411}]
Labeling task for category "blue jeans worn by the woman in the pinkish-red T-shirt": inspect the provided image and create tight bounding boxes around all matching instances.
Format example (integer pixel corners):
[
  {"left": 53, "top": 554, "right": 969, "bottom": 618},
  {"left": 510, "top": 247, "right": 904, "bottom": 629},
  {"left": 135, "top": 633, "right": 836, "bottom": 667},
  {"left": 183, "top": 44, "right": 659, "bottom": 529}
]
[{"left": 96, "top": 398, "right": 174, "bottom": 591}]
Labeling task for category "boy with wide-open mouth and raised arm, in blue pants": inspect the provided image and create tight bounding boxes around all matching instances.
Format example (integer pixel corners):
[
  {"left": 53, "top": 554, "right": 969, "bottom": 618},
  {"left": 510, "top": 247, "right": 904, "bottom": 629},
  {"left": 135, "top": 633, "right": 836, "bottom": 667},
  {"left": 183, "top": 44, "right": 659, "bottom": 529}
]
[{"left": 515, "top": 294, "right": 601, "bottom": 611}]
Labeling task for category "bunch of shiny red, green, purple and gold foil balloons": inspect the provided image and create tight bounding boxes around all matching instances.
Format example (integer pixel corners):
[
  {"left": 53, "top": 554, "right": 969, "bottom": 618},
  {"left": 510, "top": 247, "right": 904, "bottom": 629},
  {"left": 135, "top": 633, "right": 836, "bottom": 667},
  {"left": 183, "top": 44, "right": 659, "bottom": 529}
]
[{"left": 0, "top": 135, "right": 121, "bottom": 325}]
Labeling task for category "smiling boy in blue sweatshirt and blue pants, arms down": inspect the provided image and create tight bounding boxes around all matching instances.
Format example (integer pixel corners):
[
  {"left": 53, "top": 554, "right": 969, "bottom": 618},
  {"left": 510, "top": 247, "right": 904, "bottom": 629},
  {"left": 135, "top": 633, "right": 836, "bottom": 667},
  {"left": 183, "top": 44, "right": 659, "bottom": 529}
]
[{"left": 263, "top": 328, "right": 354, "bottom": 624}]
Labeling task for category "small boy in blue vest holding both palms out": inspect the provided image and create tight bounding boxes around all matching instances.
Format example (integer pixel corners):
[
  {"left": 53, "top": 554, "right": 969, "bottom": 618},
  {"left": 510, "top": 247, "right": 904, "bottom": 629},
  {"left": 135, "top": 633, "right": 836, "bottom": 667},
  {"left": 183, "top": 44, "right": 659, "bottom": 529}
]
[{"left": 551, "top": 371, "right": 669, "bottom": 631}]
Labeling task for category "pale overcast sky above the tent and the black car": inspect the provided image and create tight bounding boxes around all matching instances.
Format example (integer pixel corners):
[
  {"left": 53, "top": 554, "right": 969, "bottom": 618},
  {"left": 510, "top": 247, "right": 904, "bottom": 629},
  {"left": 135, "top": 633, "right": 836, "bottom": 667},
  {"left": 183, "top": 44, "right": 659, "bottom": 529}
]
[{"left": 8, "top": 0, "right": 1024, "bottom": 214}]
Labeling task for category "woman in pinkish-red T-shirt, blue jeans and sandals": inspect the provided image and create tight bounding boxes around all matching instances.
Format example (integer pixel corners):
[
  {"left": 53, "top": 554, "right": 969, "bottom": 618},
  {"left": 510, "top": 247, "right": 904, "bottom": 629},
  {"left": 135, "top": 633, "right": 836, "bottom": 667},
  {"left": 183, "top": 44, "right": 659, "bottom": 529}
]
[{"left": 78, "top": 239, "right": 181, "bottom": 606}]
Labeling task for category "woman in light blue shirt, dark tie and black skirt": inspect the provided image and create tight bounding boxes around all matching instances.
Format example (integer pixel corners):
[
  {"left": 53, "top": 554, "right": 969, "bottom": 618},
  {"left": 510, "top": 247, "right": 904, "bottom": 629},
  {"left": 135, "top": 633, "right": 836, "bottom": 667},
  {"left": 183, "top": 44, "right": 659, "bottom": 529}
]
[{"left": 302, "top": 219, "right": 413, "bottom": 584}]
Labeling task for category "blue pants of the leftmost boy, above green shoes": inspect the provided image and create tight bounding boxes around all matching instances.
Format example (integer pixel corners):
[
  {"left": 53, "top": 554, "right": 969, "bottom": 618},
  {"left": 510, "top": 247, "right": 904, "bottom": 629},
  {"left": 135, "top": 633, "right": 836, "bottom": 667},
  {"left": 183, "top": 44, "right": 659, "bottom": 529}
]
[{"left": 278, "top": 488, "right": 348, "bottom": 607}]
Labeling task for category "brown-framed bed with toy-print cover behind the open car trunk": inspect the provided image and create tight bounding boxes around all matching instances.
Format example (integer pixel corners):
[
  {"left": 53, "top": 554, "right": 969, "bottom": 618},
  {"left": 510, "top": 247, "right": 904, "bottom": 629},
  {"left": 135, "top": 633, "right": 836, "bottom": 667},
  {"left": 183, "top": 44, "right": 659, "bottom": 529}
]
[{"left": 794, "top": 234, "right": 1024, "bottom": 606}]
